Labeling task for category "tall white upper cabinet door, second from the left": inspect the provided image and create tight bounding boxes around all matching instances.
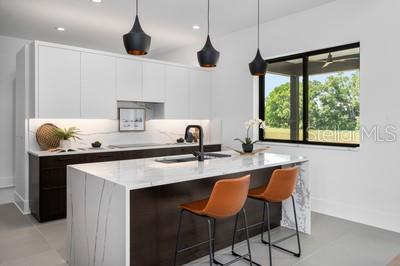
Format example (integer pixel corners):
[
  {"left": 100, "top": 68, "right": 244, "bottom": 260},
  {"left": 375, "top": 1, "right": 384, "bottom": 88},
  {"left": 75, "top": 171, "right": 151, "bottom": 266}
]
[{"left": 81, "top": 53, "right": 117, "bottom": 119}]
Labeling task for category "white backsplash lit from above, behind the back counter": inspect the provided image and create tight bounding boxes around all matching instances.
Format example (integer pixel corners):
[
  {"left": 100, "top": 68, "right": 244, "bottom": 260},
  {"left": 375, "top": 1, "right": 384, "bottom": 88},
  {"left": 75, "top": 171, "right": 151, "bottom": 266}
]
[{"left": 29, "top": 119, "right": 221, "bottom": 151}]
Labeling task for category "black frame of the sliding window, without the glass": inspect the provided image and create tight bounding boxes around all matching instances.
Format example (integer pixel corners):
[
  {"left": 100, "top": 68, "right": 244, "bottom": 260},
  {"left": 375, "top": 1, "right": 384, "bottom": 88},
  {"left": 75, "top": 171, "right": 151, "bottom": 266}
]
[{"left": 258, "top": 42, "right": 360, "bottom": 148}]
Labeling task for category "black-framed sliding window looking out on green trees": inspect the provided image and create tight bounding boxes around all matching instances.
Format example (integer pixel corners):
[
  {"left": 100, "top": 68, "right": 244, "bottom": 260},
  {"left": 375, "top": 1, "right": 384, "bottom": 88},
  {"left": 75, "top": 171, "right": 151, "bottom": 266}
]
[{"left": 259, "top": 43, "right": 360, "bottom": 147}]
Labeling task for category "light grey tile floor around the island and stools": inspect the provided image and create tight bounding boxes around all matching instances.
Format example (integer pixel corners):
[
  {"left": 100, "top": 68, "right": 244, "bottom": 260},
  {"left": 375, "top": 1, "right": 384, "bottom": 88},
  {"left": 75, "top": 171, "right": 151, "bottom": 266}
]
[{"left": 0, "top": 204, "right": 400, "bottom": 266}]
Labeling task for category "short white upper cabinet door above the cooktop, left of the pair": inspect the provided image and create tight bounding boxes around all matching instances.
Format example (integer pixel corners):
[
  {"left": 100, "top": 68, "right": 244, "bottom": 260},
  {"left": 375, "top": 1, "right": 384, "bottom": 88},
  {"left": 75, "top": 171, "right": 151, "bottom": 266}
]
[{"left": 116, "top": 58, "right": 143, "bottom": 102}]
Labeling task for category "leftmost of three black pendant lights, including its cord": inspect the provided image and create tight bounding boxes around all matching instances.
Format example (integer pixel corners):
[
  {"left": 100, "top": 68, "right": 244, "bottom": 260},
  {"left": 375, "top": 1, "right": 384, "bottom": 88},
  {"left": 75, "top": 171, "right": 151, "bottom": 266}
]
[{"left": 123, "top": 0, "right": 151, "bottom": 55}]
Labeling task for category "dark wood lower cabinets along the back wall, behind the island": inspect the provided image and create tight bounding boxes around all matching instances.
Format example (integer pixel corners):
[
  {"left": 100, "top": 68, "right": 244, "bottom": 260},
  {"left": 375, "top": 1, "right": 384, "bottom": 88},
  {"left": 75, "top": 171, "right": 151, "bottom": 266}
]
[{"left": 29, "top": 145, "right": 221, "bottom": 222}]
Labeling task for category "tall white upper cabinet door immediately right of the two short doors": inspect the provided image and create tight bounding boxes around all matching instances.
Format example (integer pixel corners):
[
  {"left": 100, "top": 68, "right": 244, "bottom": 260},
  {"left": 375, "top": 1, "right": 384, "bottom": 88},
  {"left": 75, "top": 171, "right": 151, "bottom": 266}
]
[{"left": 164, "top": 66, "right": 190, "bottom": 119}]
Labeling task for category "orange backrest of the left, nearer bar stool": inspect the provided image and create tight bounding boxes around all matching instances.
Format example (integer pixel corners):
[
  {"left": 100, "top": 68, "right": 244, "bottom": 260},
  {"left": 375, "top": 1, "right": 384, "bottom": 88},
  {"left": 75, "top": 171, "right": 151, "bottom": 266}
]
[{"left": 203, "top": 175, "right": 250, "bottom": 218}]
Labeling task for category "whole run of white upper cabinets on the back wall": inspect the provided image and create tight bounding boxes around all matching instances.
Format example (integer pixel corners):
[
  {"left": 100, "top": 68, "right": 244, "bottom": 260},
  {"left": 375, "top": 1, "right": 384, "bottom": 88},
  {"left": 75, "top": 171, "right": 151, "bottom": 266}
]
[{"left": 28, "top": 41, "right": 211, "bottom": 119}]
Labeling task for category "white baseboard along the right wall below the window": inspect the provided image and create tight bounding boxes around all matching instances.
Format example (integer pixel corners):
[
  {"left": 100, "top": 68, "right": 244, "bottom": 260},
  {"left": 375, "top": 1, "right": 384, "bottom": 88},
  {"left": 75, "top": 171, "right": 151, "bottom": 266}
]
[{"left": 311, "top": 197, "right": 400, "bottom": 233}]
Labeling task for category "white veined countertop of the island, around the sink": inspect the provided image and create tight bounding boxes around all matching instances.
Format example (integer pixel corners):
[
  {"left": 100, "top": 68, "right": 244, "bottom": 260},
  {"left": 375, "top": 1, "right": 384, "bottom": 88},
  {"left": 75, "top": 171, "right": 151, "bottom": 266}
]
[{"left": 68, "top": 151, "right": 308, "bottom": 190}]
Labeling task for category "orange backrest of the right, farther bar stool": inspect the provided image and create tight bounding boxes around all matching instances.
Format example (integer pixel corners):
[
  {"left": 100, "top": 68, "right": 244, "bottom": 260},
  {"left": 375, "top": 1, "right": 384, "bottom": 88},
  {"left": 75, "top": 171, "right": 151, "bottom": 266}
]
[{"left": 263, "top": 167, "right": 299, "bottom": 202}]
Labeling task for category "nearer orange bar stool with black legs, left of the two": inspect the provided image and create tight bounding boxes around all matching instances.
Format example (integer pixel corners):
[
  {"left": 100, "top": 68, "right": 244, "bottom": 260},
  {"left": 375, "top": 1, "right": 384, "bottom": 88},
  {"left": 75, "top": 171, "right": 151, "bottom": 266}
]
[{"left": 174, "top": 175, "right": 252, "bottom": 266}]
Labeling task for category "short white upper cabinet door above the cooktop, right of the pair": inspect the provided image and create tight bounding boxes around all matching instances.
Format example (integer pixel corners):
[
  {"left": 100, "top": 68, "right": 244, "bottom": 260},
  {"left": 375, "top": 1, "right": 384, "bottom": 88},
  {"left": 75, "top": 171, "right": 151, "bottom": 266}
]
[{"left": 143, "top": 62, "right": 165, "bottom": 103}]
